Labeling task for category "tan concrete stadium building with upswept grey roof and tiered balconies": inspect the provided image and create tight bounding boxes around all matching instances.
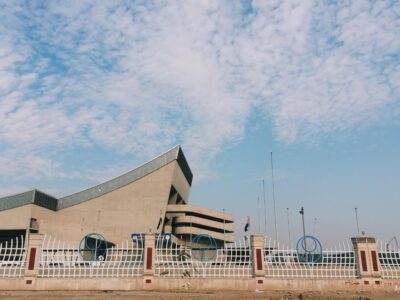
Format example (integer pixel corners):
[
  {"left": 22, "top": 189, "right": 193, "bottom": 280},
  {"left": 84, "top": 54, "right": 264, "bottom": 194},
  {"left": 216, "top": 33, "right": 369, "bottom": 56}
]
[{"left": 0, "top": 145, "right": 234, "bottom": 244}]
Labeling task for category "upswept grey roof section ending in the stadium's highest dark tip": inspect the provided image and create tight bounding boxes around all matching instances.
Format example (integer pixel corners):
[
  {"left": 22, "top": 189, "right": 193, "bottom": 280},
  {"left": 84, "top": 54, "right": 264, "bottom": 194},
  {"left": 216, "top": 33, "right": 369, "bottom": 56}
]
[{"left": 57, "top": 145, "right": 193, "bottom": 210}]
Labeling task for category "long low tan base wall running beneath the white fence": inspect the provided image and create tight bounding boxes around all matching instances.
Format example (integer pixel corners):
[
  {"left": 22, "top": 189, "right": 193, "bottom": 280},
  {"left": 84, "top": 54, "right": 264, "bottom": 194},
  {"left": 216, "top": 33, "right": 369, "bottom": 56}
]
[{"left": 0, "top": 277, "right": 400, "bottom": 292}]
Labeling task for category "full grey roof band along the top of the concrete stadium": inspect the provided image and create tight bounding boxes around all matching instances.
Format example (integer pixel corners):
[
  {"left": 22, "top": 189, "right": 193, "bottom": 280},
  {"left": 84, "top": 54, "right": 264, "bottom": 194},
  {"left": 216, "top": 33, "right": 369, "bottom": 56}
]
[{"left": 0, "top": 145, "right": 193, "bottom": 211}]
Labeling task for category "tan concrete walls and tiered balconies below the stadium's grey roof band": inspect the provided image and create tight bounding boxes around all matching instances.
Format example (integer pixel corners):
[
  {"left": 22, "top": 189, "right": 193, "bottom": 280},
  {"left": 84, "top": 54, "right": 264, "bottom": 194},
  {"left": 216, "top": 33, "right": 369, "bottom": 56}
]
[{"left": 0, "top": 160, "right": 233, "bottom": 245}]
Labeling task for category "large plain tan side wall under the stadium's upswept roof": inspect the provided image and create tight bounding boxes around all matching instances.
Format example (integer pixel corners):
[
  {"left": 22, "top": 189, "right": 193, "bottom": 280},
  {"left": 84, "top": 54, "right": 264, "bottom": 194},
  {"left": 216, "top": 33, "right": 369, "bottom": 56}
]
[{"left": 32, "top": 161, "right": 177, "bottom": 243}]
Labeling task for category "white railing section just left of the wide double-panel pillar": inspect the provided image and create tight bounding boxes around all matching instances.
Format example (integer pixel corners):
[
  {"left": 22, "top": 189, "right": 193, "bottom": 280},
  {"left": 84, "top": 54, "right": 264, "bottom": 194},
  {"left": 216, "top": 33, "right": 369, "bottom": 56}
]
[{"left": 264, "top": 240, "right": 357, "bottom": 279}]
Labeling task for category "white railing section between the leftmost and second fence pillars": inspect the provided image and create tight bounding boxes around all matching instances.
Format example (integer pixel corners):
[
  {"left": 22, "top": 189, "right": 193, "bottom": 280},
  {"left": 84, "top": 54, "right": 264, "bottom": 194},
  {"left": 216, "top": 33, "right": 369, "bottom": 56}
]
[{"left": 38, "top": 236, "right": 144, "bottom": 278}]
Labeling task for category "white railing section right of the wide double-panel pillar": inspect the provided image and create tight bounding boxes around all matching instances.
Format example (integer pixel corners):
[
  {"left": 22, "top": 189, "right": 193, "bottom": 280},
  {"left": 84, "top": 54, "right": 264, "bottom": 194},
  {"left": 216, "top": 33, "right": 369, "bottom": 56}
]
[{"left": 378, "top": 241, "right": 400, "bottom": 279}]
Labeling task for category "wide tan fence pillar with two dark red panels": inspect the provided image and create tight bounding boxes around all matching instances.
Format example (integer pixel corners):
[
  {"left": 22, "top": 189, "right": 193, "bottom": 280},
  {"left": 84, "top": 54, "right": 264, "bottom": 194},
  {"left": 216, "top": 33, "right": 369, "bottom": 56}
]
[{"left": 351, "top": 237, "right": 381, "bottom": 278}]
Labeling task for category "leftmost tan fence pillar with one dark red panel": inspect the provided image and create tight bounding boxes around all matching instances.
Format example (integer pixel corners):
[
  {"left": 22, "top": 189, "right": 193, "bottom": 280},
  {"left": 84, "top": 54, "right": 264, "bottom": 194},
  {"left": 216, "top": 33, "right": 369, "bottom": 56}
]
[{"left": 24, "top": 233, "right": 44, "bottom": 284}]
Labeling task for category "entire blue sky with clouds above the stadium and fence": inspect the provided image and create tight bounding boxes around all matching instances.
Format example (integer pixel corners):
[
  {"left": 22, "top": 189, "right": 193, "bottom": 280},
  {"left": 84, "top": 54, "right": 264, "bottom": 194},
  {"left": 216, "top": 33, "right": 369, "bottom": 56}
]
[{"left": 0, "top": 0, "right": 400, "bottom": 245}]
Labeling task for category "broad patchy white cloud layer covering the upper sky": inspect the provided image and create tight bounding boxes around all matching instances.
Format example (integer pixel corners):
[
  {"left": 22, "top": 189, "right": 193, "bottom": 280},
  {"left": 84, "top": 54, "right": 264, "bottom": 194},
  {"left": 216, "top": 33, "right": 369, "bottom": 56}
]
[{"left": 0, "top": 1, "right": 400, "bottom": 190}]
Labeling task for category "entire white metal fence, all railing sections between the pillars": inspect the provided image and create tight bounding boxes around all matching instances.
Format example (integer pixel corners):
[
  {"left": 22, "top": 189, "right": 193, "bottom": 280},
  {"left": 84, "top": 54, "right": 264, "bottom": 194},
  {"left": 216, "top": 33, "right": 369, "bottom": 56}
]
[{"left": 0, "top": 235, "right": 400, "bottom": 279}]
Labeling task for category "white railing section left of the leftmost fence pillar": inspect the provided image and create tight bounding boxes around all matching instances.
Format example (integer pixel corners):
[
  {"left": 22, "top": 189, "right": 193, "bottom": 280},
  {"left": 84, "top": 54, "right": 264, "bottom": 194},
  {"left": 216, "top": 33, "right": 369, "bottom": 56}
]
[{"left": 0, "top": 236, "right": 26, "bottom": 277}]
